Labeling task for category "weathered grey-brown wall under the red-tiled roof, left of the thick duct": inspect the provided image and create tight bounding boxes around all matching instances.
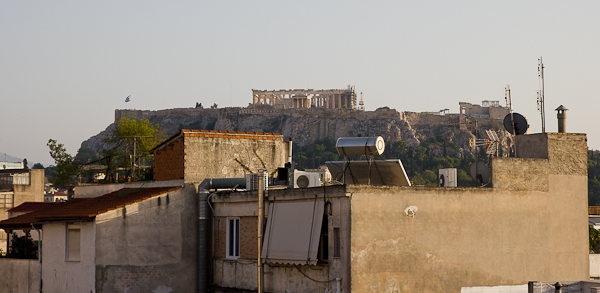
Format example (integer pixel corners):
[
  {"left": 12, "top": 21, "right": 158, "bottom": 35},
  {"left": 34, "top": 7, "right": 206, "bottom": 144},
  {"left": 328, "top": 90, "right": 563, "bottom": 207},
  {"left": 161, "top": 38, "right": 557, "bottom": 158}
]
[{"left": 95, "top": 185, "right": 197, "bottom": 293}]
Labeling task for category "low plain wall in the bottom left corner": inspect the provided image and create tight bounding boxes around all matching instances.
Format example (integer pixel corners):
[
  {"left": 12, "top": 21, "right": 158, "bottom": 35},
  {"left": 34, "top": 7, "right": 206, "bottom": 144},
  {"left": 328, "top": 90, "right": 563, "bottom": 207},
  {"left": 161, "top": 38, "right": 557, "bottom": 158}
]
[{"left": 0, "top": 258, "right": 40, "bottom": 293}]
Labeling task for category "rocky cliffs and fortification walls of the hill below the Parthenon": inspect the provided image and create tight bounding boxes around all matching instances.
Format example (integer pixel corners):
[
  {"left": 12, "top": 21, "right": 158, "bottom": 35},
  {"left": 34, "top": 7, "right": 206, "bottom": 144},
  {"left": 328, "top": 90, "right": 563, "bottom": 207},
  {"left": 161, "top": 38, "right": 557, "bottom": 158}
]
[{"left": 81, "top": 96, "right": 511, "bottom": 160}]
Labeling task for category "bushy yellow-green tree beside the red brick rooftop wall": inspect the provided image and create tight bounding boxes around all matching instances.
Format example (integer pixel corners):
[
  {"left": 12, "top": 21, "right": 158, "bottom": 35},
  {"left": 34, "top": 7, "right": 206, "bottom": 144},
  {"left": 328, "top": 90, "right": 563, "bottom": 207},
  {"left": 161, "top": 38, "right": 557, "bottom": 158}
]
[{"left": 102, "top": 116, "right": 165, "bottom": 180}]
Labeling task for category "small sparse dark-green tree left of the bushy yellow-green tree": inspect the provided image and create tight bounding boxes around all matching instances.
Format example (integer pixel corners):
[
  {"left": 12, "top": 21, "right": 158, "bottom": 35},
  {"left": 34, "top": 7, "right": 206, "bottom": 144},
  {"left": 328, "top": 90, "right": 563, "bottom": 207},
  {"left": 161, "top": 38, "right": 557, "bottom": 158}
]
[{"left": 46, "top": 139, "right": 79, "bottom": 186}]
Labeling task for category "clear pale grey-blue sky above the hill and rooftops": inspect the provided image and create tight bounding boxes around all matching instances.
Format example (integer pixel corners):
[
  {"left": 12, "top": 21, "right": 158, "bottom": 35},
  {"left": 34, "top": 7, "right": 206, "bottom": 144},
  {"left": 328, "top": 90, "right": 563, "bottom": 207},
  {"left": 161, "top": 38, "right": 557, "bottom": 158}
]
[{"left": 0, "top": 0, "right": 600, "bottom": 166}]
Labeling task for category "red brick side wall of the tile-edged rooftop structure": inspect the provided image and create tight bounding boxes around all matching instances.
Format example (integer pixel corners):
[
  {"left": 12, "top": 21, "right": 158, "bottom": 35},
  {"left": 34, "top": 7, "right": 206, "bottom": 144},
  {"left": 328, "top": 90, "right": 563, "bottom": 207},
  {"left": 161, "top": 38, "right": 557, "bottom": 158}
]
[{"left": 154, "top": 137, "right": 184, "bottom": 181}]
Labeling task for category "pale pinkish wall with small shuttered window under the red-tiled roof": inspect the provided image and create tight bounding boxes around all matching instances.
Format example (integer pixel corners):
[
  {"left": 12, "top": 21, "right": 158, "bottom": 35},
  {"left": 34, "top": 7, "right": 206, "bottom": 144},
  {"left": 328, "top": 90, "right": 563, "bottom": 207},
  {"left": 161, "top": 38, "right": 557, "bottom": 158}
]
[{"left": 42, "top": 222, "right": 96, "bottom": 293}]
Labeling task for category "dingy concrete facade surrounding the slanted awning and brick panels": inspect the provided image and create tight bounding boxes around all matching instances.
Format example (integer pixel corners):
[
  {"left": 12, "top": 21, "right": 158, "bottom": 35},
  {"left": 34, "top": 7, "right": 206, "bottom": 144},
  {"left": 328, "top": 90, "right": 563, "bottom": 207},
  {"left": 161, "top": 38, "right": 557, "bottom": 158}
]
[{"left": 212, "top": 186, "right": 350, "bottom": 292}]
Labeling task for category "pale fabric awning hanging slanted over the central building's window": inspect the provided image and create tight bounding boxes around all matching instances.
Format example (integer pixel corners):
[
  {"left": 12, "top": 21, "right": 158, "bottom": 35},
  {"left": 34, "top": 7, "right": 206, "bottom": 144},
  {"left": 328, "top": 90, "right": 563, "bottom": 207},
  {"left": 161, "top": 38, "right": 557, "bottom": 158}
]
[{"left": 261, "top": 200, "right": 324, "bottom": 265}]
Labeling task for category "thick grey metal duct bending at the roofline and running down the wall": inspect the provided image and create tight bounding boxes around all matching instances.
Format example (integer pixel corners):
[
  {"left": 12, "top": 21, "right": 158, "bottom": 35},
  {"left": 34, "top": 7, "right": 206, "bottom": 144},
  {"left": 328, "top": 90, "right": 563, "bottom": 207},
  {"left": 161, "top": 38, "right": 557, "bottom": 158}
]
[{"left": 197, "top": 178, "right": 246, "bottom": 292}]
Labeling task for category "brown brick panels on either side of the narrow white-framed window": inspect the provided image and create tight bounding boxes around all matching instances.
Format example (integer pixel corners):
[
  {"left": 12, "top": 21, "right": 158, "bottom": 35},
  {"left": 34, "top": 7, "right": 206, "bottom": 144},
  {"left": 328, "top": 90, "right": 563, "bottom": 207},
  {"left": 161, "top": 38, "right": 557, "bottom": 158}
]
[{"left": 214, "top": 213, "right": 258, "bottom": 260}]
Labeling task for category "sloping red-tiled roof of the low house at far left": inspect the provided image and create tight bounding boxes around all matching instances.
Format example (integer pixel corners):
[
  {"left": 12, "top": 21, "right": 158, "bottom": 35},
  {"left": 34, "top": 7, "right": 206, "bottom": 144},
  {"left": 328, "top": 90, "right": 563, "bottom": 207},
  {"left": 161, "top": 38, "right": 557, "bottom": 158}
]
[{"left": 0, "top": 187, "right": 180, "bottom": 229}]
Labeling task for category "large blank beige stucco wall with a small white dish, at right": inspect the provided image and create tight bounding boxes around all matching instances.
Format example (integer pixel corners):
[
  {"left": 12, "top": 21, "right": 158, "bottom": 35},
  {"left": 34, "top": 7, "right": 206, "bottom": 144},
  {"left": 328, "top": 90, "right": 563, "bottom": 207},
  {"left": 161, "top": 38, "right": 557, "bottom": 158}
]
[{"left": 348, "top": 171, "right": 589, "bottom": 292}]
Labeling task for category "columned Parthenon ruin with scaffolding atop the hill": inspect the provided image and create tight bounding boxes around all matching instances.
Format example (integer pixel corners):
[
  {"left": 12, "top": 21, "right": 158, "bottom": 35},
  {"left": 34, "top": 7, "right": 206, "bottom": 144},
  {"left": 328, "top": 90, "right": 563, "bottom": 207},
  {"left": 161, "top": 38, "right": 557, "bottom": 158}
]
[{"left": 252, "top": 86, "right": 356, "bottom": 109}]
